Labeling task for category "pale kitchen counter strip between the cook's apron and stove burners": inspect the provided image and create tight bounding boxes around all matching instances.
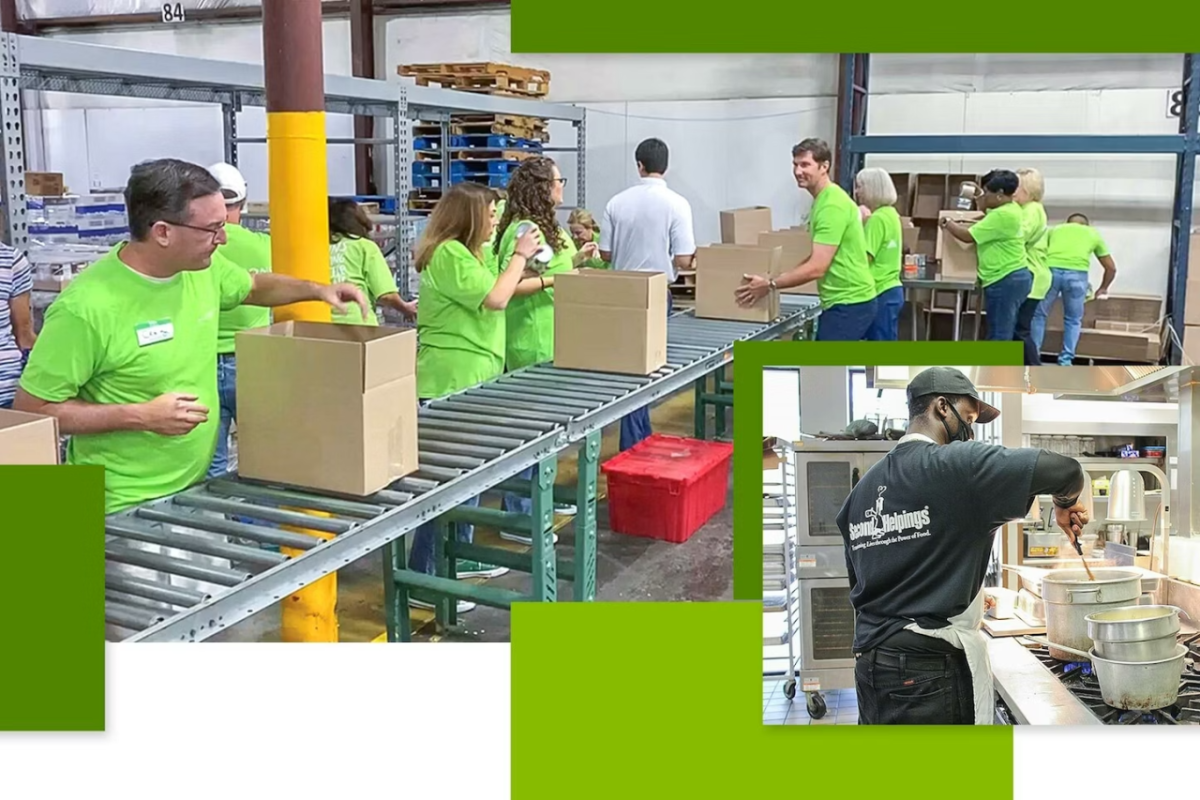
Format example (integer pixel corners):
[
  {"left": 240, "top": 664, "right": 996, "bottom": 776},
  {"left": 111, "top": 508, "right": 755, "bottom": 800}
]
[{"left": 984, "top": 633, "right": 1104, "bottom": 726}]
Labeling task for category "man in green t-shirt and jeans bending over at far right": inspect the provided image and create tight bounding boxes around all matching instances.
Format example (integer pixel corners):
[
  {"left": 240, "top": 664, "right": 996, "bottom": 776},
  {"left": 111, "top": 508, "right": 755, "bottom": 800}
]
[{"left": 1032, "top": 213, "right": 1117, "bottom": 367}]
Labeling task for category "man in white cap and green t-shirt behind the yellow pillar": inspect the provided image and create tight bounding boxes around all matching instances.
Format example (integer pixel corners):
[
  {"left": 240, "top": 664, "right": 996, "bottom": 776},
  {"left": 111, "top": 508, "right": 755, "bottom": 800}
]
[{"left": 209, "top": 163, "right": 271, "bottom": 477}]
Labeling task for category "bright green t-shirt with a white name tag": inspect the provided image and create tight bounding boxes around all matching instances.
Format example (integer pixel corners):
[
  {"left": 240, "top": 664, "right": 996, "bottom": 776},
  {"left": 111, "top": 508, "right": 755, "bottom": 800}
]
[{"left": 20, "top": 245, "right": 253, "bottom": 513}]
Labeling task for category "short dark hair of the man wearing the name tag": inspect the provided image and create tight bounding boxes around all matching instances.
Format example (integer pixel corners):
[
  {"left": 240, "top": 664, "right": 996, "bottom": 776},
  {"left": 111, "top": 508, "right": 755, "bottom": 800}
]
[{"left": 125, "top": 158, "right": 224, "bottom": 241}]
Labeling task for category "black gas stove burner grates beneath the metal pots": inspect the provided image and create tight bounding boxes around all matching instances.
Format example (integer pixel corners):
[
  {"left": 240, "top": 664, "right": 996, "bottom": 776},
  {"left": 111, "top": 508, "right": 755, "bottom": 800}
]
[{"left": 1026, "top": 633, "right": 1200, "bottom": 724}]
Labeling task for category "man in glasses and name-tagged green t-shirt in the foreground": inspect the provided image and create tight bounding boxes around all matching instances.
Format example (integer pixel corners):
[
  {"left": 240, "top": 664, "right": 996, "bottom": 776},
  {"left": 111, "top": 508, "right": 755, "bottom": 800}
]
[{"left": 14, "top": 158, "right": 366, "bottom": 513}]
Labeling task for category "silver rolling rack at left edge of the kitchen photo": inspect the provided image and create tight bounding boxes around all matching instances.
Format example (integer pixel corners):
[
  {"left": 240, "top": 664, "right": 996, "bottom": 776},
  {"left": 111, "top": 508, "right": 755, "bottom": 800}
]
[{"left": 762, "top": 443, "right": 800, "bottom": 700}]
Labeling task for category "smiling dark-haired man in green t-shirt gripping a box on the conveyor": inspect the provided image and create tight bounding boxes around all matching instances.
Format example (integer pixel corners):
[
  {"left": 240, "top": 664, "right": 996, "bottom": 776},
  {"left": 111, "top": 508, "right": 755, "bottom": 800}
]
[{"left": 736, "top": 139, "right": 877, "bottom": 342}]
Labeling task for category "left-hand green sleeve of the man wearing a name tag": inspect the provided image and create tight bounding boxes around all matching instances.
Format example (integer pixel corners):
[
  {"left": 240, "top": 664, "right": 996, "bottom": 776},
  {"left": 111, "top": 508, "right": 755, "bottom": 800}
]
[{"left": 20, "top": 300, "right": 104, "bottom": 403}]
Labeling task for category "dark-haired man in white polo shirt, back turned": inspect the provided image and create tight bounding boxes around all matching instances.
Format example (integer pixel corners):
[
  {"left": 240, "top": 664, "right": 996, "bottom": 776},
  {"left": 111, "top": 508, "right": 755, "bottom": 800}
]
[{"left": 600, "top": 139, "right": 696, "bottom": 450}]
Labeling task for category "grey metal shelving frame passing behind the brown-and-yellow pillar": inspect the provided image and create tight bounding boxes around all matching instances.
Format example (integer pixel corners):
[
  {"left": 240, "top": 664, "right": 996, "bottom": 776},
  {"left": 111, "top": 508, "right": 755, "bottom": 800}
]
[{"left": 0, "top": 34, "right": 587, "bottom": 294}]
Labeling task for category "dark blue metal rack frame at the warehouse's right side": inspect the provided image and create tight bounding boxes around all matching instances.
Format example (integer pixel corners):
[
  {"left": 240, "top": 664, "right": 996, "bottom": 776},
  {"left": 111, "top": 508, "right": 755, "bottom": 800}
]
[{"left": 838, "top": 53, "right": 1200, "bottom": 365}]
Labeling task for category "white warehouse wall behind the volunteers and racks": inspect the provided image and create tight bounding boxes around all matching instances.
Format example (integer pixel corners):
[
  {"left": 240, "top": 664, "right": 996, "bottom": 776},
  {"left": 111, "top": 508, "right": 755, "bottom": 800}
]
[{"left": 21, "top": 11, "right": 1200, "bottom": 294}]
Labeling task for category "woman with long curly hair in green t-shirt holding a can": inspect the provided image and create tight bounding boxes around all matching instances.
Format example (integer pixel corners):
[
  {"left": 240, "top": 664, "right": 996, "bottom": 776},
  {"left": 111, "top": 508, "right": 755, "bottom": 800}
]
[{"left": 494, "top": 156, "right": 600, "bottom": 545}]
